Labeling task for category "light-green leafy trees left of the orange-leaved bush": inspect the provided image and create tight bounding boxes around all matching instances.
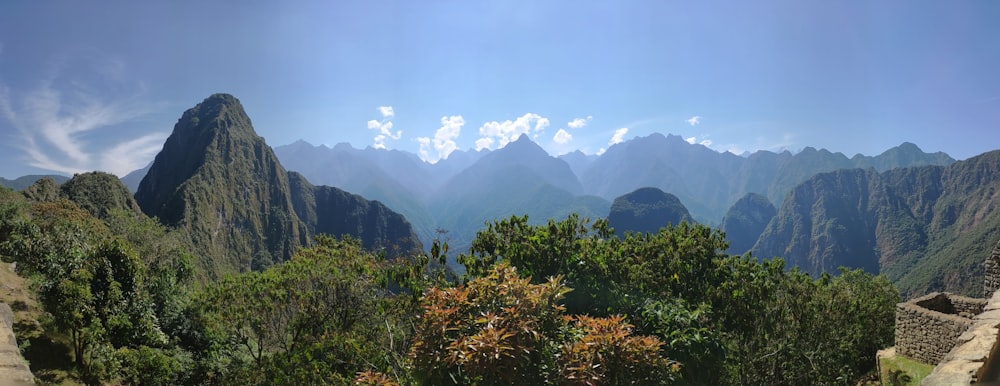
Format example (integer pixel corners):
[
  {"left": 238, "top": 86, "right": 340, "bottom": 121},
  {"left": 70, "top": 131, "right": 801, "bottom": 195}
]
[{"left": 199, "top": 236, "right": 413, "bottom": 384}]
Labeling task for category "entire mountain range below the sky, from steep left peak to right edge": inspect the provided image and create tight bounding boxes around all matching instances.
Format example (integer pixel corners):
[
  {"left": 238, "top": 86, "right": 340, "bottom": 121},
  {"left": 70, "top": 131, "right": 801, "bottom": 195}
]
[{"left": 9, "top": 94, "right": 1000, "bottom": 294}]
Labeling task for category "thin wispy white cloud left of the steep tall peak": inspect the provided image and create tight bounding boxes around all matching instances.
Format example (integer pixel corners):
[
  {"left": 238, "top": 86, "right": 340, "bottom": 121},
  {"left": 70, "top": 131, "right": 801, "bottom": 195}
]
[{"left": 0, "top": 76, "right": 166, "bottom": 176}]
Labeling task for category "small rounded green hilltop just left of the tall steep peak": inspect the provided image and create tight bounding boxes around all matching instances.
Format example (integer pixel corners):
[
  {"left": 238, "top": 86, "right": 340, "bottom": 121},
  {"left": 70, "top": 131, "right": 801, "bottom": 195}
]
[{"left": 59, "top": 172, "right": 142, "bottom": 219}]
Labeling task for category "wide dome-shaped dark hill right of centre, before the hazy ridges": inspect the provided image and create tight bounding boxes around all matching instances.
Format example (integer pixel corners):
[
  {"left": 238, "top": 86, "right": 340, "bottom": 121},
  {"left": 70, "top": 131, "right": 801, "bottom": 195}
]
[{"left": 608, "top": 188, "right": 692, "bottom": 237}]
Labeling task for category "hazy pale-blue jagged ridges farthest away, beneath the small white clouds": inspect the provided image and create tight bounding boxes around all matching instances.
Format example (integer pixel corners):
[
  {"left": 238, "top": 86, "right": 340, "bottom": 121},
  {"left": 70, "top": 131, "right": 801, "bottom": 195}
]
[{"left": 266, "top": 134, "right": 953, "bottom": 256}]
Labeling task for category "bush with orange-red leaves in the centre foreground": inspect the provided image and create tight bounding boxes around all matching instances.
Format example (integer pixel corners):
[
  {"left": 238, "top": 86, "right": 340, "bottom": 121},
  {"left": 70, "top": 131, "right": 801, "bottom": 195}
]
[{"left": 410, "top": 264, "right": 677, "bottom": 385}]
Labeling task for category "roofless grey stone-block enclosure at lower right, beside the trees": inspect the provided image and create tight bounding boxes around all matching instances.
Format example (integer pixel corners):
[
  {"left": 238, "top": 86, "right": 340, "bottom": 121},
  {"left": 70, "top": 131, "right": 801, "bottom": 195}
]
[{"left": 896, "top": 292, "right": 985, "bottom": 365}]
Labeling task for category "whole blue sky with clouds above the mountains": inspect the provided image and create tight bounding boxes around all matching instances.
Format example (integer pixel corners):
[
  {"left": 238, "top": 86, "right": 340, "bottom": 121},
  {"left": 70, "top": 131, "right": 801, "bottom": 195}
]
[{"left": 0, "top": 0, "right": 1000, "bottom": 178}]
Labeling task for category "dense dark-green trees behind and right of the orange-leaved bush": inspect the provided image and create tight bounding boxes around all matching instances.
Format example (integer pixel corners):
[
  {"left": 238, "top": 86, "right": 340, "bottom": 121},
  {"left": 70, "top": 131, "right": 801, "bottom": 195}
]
[{"left": 460, "top": 216, "right": 899, "bottom": 384}]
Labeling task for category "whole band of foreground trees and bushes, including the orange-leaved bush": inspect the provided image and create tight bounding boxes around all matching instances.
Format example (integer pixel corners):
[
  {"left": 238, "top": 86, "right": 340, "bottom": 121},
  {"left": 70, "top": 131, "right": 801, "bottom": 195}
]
[{"left": 0, "top": 173, "right": 899, "bottom": 385}]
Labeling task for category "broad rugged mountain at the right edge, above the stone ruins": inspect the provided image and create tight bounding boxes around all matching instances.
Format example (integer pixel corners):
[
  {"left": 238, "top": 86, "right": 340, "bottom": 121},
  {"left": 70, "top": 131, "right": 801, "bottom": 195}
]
[{"left": 753, "top": 151, "right": 1000, "bottom": 296}]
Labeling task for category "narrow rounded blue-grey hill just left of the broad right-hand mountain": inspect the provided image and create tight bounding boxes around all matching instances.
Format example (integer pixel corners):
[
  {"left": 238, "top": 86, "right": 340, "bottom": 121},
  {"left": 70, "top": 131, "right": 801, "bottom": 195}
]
[{"left": 721, "top": 193, "right": 777, "bottom": 255}]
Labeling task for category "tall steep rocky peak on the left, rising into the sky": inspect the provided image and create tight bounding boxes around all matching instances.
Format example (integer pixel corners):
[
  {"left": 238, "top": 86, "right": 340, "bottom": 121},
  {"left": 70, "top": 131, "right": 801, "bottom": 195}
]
[{"left": 135, "top": 94, "right": 307, "bottom": 273}]
